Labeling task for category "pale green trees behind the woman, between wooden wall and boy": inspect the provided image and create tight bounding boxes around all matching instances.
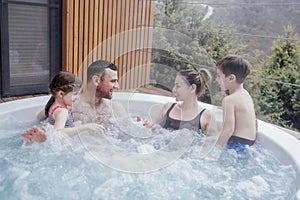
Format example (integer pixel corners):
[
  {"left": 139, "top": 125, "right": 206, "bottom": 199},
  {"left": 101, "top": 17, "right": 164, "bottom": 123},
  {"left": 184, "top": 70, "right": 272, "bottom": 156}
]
[{"left": 150, "top": 0, "right": 243, "bottom": 104}]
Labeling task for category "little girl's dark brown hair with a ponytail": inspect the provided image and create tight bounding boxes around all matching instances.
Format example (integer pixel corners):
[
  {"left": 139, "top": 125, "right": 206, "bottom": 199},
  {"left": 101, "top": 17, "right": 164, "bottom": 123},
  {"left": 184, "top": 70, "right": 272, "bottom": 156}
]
[{"left": 45, "top": 71, "right": 82, "bottom": 117}]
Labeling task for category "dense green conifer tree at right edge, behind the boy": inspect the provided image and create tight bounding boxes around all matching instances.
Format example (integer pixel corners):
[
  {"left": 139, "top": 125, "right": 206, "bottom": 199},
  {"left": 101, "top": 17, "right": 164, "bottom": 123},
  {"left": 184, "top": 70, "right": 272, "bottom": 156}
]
[{"left": 258, "top": 25, "right": 300, "bottom": 130}]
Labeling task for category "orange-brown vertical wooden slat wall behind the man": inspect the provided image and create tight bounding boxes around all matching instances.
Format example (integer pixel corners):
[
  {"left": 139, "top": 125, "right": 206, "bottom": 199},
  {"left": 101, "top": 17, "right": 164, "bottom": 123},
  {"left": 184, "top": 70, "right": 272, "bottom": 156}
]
[{"left": 62, "top": 0, "right": 154, "bottom": 89}]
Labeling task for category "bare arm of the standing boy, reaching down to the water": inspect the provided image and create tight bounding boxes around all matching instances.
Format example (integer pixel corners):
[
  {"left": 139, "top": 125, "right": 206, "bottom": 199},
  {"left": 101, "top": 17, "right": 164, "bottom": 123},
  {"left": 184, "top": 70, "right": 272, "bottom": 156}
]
[{"left": 217, "top": 96, "right": 235, "bottom": 146}]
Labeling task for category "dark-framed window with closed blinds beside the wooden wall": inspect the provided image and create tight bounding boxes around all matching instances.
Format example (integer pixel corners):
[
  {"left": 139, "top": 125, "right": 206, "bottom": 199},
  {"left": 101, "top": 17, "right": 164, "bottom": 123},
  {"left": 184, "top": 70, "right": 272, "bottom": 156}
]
[{"left": 0, "top": 0, "right": 61, "bottom": 97}]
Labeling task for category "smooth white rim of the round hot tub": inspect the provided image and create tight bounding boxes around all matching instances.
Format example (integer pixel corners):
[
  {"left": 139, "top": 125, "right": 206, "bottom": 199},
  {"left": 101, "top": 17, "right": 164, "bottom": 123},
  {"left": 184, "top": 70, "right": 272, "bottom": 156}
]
[{"left": 0, "top": 92, "right": 300, "bottom": 199}]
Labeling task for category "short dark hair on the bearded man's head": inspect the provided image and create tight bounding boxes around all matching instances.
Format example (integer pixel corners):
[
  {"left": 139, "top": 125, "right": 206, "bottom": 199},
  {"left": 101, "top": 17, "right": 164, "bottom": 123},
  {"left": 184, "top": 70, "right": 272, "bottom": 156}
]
[{"left": 87, "top": 60, "right": 117, "bottom": 82}]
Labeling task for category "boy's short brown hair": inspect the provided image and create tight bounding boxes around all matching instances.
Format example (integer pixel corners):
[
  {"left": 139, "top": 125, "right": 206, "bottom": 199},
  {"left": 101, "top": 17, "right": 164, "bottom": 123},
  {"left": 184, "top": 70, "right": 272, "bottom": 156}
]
[{"left": 217, "top": 55, "right": 251, "bottom": 83}]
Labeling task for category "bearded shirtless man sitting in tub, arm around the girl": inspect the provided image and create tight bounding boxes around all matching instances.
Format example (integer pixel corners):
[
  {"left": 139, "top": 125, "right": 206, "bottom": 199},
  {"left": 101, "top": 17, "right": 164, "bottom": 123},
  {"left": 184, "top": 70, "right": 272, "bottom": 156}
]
[{"left": 21, "top": 60, "right": 142, "bottom": 144}]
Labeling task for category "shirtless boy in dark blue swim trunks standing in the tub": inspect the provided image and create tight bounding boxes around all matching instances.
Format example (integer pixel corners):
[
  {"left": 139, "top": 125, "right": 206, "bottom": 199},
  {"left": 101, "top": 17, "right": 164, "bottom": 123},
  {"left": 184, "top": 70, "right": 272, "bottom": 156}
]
[{"left": 216, "top": 55, "right": 257, "bottom": 151}]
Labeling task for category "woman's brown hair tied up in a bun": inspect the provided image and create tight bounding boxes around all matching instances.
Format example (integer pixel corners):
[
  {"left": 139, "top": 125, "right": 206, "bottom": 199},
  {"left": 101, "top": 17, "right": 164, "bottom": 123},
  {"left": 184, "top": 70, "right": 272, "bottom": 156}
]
[{"left": 178, "top": 68, "right": 212, "bottom": 97}]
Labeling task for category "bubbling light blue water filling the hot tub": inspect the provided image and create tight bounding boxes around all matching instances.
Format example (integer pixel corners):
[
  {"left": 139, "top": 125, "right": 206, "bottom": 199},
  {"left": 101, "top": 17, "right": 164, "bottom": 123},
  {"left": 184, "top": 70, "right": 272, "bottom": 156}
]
[{"left": 0, "top": 118, "right": 296, "bottom": 200}]
